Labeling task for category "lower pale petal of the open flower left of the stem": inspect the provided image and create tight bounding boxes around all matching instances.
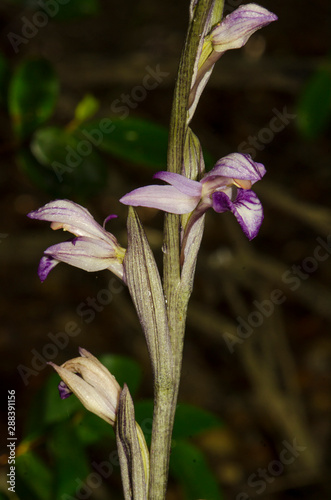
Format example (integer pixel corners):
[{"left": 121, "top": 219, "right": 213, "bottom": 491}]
[{"left": 45, "top": 237, "right": 121, "bottom": 272}]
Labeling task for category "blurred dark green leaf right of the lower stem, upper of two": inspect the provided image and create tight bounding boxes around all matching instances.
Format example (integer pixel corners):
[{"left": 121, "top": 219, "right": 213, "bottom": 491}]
[{"left": 172, "top": 403, "right": 223, "bottom": 439}]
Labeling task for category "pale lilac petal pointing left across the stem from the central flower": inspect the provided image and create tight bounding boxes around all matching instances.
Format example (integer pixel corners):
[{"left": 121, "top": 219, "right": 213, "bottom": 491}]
[{"left": 120, "top": 186, "right": 200, "bottom": 214}]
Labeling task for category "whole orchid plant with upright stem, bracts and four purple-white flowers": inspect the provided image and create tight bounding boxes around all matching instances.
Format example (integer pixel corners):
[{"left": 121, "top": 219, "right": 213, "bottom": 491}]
[{"left": 29, "top": 0, "right": 277, "bottom": 500}]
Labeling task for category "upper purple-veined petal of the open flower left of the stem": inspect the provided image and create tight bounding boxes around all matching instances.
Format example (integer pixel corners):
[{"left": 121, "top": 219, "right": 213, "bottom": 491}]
[{"left": 28, "top": 200, "right": 113, "bottom": 244}]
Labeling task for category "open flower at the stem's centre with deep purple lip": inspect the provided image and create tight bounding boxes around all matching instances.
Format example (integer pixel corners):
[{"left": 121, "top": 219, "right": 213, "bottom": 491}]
[{"left": 120, "top": 153, "right": 265, "bottom": 240}]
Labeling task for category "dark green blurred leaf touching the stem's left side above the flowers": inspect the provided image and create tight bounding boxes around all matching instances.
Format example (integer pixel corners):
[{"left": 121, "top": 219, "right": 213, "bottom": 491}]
[{"left": 84, "top": 117, "right": 168, "bottom": 169}]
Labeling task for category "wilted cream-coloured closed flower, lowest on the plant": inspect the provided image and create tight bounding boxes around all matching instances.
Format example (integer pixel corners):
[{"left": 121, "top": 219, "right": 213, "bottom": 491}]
[{"left": 48, "top": 347, "right": 121, "bottom": 425}]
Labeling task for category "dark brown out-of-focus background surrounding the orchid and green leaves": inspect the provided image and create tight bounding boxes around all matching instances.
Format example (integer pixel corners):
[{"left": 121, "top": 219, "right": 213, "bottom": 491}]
[{"left": 0, "top": 0, "right": 331, "bottom": 500}]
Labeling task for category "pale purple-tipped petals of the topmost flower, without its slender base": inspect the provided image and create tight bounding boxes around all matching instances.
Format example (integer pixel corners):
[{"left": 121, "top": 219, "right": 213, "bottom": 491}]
[{"left": 210, "top": 3, "right": 278, "bottom": 52}]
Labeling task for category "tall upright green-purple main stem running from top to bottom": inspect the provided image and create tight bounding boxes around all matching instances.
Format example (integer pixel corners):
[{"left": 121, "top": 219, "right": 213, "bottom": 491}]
[{"left": 149, "top": 0, "right": 223, "bottom": 500}]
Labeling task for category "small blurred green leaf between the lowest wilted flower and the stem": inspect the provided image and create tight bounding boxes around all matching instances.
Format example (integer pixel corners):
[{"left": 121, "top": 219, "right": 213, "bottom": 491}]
[{"left": 99, "top": 354, "right": 141, "bottom": 396}]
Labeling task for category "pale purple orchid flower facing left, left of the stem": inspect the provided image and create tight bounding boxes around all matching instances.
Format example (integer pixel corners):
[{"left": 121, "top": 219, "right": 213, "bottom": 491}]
[{"left": 28, "top": 200, "right": 125, "bottom": 281}]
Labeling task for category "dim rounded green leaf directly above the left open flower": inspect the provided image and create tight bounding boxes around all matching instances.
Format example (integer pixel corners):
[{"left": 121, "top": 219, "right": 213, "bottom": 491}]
[{"left": 27, "top": 127, "right": 107, "bottom": 197}]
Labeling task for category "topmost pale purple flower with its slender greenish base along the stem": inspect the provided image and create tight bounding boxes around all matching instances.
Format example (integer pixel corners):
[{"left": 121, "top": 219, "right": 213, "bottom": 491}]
[{"left": 189, "top": 3, "right": 278, "bottom": 117}]
